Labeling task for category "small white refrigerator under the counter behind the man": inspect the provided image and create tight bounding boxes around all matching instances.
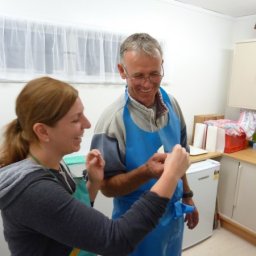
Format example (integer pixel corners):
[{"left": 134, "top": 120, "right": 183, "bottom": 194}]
[{"left": 182, "top": 159, "right": 220, "bottom": 249}]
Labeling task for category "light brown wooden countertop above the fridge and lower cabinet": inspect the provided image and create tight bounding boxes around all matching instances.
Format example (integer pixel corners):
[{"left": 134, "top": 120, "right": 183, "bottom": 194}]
[{"left": 190, "top": 148, "right": 256, "bottom": 165}]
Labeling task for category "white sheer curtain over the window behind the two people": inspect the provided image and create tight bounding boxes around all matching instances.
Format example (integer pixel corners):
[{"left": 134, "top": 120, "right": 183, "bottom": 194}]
[{"left": 0, "top": 17, "right": 124, "bottom": 84}]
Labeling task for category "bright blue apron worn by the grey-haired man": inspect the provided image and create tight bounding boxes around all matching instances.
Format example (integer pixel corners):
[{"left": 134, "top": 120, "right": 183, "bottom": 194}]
[{"left": 112, "top": 88, "right": 193, "bottom": 256}]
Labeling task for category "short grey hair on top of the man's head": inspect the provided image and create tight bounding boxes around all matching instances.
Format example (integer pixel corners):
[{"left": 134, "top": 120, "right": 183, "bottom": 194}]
[{"left": 120, "top": 33, "right": 163, "bottom": 62}]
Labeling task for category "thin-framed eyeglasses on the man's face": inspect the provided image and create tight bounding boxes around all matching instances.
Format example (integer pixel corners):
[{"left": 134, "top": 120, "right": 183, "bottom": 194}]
[{"left": 122, "top": 64, "right": 164, "bottom": 84}]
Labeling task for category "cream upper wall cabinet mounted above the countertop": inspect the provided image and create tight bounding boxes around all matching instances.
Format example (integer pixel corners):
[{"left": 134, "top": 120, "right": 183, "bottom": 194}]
[{"left": 228, "top": 39, "right": 256, "bottom": 109}]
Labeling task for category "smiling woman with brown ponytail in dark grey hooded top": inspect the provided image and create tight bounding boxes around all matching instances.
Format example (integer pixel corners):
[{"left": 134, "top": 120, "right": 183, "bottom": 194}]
[{"left": 0, "top": 77, "right": 189, "bottom": 256}]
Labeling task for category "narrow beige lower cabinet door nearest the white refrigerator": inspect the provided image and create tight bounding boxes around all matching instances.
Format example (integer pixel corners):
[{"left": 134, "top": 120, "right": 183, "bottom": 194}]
[{"left": 218, "top": 157, "right": 239, "bottom": 218}]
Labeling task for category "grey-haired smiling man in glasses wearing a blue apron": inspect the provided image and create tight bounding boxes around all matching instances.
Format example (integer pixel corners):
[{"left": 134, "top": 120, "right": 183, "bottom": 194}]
[{"left": 91, "top": 33, "right": 198, "bottom": 256}]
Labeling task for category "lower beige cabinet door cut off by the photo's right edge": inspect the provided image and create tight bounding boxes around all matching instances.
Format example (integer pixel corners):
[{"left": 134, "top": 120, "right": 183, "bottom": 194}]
[{"left": 233, "top": 162, "right": 256, "bottom": 232}]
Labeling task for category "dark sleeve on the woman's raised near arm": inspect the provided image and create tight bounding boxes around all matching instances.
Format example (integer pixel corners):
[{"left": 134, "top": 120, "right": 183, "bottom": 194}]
[{"left": 11, "top": 180, "right": 169, "bottom": 256}]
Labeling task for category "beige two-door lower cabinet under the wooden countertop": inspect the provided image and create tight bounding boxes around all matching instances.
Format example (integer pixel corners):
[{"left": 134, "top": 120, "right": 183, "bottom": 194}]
[{"left": 218, "top": 156, "right": 256, "bottom": 234}]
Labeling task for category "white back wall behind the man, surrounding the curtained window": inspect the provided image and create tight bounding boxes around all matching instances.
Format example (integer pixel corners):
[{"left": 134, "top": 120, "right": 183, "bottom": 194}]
[{"left": 0, "top": 0, "right": 234, "bottom": 147}]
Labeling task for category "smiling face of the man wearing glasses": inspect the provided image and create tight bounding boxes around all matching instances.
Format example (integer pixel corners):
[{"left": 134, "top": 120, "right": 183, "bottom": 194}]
[{"left": 118, "top": 51, "right": 163, "bottom": 107}]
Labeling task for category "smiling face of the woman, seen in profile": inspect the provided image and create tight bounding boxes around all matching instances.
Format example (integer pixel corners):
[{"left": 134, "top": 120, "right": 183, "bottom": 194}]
[{"left": 48, "top": 98, "right": 91, "bottom": 155}]
